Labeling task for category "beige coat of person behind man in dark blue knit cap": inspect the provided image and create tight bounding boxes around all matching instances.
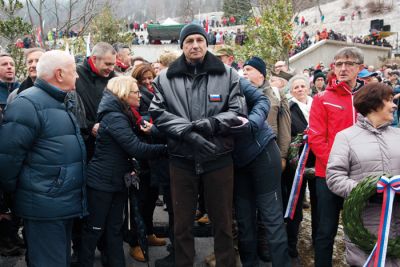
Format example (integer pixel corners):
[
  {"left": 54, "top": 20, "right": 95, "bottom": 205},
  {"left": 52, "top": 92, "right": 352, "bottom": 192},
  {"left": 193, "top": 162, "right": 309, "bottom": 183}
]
[{"left": 260, "top": 82, "right": 291, "bottom": 159}]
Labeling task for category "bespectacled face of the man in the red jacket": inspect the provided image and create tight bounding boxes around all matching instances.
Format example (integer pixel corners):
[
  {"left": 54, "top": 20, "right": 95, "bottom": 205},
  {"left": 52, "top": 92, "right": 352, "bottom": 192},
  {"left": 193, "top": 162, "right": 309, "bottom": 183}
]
[{"left": 335, "top": 57, "right": 363, "bottom": 84}]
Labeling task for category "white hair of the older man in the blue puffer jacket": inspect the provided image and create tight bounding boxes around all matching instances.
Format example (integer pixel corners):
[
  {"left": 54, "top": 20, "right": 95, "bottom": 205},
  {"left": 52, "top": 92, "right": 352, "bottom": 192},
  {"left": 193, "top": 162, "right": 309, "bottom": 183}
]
[{"left": 36, "top": 50, "right": 75, "bottom": 79}]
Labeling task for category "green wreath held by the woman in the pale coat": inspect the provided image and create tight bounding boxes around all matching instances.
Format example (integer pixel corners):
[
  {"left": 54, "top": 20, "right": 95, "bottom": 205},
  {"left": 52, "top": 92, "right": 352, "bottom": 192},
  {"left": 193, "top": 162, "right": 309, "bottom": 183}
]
[{"left": 342, "top": 176, "right": 400, "bottom": 258}]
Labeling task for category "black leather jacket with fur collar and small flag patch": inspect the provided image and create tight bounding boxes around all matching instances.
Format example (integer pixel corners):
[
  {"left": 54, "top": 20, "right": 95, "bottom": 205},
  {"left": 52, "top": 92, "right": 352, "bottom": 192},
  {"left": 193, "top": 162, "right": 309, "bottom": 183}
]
[{"left": 150, "top": 52, "right": 247, "bottom": 174}]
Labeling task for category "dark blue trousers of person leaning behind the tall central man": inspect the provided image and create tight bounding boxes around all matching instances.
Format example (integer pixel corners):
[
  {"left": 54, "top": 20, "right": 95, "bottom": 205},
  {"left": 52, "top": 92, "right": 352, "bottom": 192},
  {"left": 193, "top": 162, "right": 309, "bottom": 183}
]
[{"left": 234, "top": 140, "right": 291, "bottom": 267}]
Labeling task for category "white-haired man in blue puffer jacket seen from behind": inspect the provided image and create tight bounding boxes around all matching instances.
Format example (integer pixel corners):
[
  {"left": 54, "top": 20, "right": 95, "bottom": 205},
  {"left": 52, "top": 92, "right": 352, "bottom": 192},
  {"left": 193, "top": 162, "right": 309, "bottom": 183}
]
[{"left": 0, "top": 51, "right": 87, "bottom": 267}]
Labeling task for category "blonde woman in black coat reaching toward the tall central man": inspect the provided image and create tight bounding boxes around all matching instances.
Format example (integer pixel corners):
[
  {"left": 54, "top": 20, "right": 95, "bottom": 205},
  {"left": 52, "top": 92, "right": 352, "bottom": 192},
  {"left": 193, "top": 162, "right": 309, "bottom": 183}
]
[{"left": 79, "top": 77, "right": 167, "bottom": 267}]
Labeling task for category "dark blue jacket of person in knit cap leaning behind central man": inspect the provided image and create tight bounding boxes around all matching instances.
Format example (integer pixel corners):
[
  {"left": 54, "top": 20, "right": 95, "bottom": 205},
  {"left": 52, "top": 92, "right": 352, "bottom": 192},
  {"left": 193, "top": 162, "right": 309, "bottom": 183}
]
[{"left": 233, "top": 78, "right": 276, "bottom": 168}]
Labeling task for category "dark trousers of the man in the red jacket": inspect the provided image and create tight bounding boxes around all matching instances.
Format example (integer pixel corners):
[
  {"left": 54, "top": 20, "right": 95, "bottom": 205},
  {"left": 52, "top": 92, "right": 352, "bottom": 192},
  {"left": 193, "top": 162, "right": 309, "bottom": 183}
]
[{"left": 315, "top": 177, "right": 343, "bottom": 267}]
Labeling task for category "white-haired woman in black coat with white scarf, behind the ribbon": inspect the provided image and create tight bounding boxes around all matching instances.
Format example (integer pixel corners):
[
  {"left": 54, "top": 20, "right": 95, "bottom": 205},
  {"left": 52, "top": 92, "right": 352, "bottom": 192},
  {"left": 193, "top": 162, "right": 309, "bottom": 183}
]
[{"left": 282, "top": 75, "right": 317, "bottom": 258}]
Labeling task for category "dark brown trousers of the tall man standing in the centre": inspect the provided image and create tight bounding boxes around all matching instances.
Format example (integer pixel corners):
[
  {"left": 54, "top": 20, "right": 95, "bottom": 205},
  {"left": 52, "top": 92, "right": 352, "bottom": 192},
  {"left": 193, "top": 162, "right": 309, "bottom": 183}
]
[{"left": 170, "top": 162, "right": 235, "bottom": 267}]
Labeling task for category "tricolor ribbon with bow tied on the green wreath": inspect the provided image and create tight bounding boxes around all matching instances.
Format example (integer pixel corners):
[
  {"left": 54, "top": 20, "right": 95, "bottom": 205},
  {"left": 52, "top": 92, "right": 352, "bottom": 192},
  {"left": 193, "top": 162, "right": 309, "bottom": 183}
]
[{"left": 364, "top": 175, "right": 400, "bottom": 267}]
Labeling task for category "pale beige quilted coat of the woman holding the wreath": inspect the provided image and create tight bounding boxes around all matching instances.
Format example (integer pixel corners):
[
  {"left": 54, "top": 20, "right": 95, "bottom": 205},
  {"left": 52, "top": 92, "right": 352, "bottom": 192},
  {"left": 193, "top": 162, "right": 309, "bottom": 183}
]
[{"left": 326, "top": 115, "right": 400, "bottom": 267}]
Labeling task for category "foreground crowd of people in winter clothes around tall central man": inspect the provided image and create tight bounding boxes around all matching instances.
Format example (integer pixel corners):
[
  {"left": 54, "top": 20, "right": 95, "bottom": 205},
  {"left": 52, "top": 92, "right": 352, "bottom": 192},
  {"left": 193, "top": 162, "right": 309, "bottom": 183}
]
[{"left": 0, "top": 24, "right": 400, "bottom": 267}]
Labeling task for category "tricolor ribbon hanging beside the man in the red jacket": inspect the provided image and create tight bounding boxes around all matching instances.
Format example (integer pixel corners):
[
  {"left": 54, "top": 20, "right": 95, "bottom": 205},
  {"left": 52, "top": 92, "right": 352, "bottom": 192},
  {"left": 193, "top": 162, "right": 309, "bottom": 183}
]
[{"left": 285, "top": 135, "right": 310, "bottom": 220}]
